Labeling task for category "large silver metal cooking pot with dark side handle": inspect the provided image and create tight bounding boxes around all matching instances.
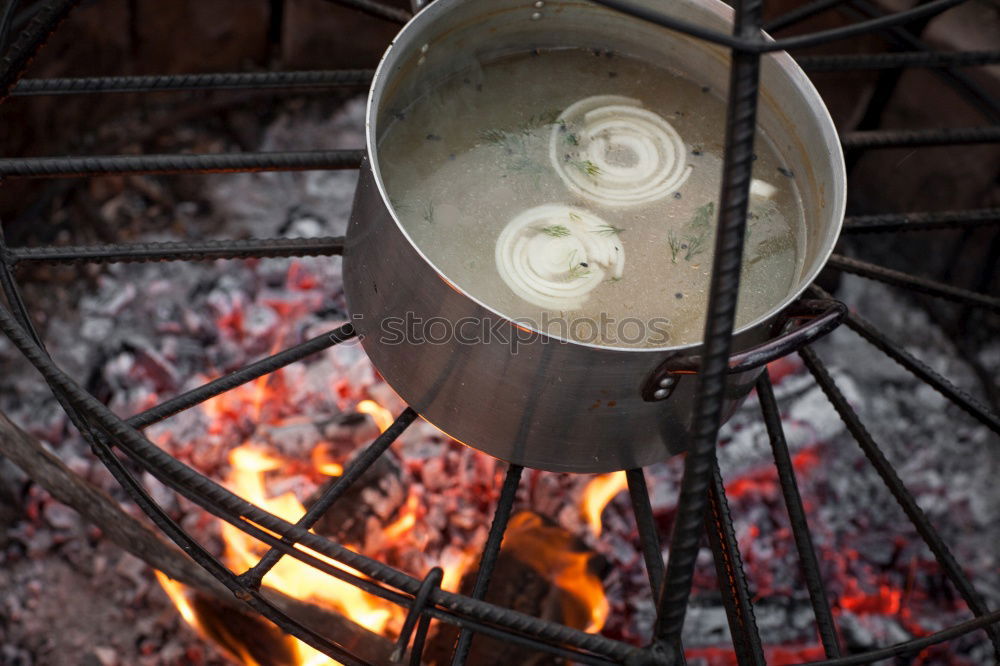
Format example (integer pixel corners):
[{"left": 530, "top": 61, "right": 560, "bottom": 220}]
[{"left": 344, "top": 0, "right": 846, "bottom": 472}]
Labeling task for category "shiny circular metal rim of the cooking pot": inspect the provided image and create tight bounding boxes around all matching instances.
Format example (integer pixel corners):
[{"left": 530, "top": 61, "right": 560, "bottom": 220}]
[{"left": 365, "top": 0, "right": 847, "bottom": 354}]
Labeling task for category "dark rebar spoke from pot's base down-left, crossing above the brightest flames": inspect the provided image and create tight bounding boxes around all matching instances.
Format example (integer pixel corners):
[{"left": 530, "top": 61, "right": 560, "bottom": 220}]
[{"left": 240, "top": 407, "right": 417, "bottom": 589}]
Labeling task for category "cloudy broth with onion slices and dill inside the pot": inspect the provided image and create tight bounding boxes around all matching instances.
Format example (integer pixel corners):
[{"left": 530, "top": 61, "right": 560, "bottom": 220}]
[{"left": 378, "top": 49, "right": 805, "bottom": 348}]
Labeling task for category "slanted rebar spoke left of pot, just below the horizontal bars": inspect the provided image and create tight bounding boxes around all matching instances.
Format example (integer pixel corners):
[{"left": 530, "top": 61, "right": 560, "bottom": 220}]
[{"left": 125, "top": 324, "right": 357, "bottom": 430}]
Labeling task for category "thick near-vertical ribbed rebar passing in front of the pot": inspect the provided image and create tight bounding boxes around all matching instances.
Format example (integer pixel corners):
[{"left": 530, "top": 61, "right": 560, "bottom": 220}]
[{"left": 656, "top": 0, "right": 762, "bottom": 647}]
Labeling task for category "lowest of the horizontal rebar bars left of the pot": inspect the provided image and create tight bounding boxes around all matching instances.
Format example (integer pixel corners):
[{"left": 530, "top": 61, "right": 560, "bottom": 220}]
[{"left": 7, "top": 236, "right": 344, "bottom": 264}]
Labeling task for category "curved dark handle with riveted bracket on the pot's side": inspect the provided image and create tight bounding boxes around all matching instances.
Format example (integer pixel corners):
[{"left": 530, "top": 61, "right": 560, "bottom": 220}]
[{"left": 642, "top": 299, "right": 847, "bottom": 402}]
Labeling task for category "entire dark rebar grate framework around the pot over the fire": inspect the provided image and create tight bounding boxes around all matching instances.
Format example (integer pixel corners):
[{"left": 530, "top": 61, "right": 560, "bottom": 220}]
[{"left": 0, "top": 0, "right": 1000, "bottom": 666}]
